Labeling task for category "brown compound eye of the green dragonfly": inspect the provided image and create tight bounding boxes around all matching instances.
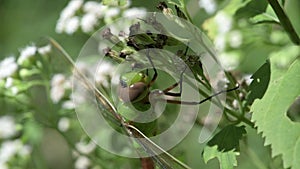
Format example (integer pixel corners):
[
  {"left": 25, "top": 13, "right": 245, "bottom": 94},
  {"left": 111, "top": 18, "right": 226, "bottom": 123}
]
[{"left": 118, "top": 82, "right": 147, "bottom": 103}]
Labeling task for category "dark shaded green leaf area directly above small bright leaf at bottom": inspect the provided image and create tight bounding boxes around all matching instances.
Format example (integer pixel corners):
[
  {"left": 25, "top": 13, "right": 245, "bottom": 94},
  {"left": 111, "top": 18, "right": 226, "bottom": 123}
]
[{"left": 208, "top": 125, "right": 246, "bottom": 152}]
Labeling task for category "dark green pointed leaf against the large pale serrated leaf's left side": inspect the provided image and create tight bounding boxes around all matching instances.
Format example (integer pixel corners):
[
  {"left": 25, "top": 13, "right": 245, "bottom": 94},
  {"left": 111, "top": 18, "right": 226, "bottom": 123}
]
[{"left": 246, "top": 61, "right": 271, "bottom": 105}]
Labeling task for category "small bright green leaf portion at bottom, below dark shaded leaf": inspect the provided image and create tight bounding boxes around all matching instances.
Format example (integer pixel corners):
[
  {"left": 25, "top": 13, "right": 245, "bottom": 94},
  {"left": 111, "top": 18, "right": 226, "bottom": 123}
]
[{"left": 203, "top": 146, "right": 239, "bottom": 169}]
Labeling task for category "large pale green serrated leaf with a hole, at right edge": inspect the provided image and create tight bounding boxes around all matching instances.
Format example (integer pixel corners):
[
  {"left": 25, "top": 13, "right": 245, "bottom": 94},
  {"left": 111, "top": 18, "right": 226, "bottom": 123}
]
[{"left": 251, "top": 58, "right": 300, "bottom": 169}]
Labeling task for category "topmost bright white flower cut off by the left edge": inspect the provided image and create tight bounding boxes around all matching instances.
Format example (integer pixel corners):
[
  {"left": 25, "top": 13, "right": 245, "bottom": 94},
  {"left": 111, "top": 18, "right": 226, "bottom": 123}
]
[{"left": 0, "top": 56, "right": 18, "bottom": 79}]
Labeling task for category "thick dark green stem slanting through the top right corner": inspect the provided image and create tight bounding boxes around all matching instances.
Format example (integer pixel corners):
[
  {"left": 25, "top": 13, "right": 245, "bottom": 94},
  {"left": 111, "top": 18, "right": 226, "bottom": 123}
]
[{"left": 268, "top": 0, "right": 300, "bottom": 45}]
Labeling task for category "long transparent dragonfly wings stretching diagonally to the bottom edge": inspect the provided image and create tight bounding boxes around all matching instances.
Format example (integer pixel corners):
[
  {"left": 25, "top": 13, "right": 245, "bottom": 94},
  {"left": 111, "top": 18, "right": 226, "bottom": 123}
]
[{"left": 49, "top": 38, "right": 189, "bottom": 169}]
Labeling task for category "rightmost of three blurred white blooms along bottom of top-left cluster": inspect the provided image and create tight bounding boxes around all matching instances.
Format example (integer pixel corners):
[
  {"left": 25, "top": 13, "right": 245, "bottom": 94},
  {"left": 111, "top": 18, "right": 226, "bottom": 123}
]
[{"left": 80, "top": 13, "right": 98, "bottom": 33}]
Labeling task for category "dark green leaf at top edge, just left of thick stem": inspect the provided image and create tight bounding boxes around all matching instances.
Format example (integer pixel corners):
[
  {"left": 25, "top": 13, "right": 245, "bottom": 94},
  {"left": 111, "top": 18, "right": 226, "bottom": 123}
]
[{"left": 234, "top": 0, "right": 268, "bottom": 19}]
